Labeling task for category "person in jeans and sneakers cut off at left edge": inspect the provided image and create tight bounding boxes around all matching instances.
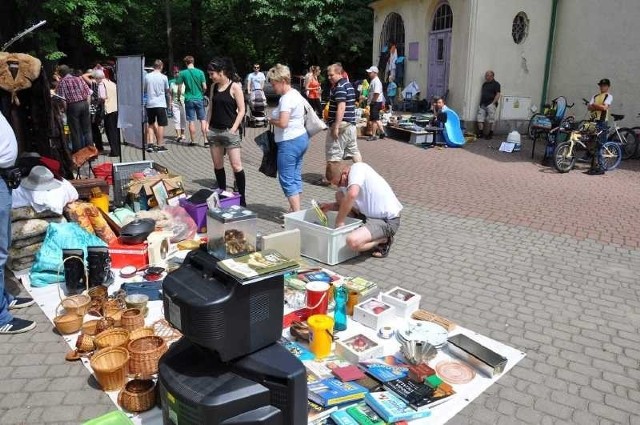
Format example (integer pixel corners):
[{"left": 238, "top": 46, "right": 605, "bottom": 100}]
[{"left": 0, "top": 112, "right": 36, "bottom": 335}]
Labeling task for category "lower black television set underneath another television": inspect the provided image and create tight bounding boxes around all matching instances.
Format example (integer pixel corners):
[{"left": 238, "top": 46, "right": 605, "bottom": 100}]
[{"left": 158, "top": 338, "right": 307, "bottom": 425}]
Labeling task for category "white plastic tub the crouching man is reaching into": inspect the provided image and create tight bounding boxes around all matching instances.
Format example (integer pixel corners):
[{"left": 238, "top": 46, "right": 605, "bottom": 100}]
[{"left": 284, "top": 209, "right": 362, "bottom": 266}]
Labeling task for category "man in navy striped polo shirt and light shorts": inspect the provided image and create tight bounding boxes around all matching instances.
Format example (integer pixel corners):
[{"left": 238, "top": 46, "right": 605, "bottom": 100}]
[{"left": 323, "top": 63, "right": 362, "bottom": 183}]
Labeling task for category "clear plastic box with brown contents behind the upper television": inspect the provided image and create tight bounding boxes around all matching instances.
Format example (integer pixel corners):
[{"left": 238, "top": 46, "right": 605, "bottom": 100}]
[{"left": 207, "top": 205, "right": 258, "bottom": 260}]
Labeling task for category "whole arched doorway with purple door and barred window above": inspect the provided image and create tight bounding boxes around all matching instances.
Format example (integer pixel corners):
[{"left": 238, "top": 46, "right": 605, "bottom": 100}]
[{"left": 427, "top": 3, "right": 453, "bottom": 98}]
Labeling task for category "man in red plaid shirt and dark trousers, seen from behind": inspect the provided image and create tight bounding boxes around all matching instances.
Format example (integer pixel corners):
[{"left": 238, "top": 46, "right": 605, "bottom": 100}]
[{"left": 56, "top": 65, "right": 93, "bottom": 152}]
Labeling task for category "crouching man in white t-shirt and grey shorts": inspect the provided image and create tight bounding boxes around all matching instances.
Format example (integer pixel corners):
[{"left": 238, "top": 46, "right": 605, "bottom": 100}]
[{"left": 320, "top": 162, "right": 402, "bottom": 258}]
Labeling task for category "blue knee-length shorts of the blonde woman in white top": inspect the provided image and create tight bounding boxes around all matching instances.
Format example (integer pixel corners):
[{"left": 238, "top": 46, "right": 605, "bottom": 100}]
[{"left": 278, "top": 133, "right": 309, "bottom": 198}]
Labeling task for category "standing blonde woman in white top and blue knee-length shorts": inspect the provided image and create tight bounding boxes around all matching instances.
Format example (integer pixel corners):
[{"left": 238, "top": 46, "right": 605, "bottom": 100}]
[{"left": 267, "top": 64, "right": 309, "bottom": 212}]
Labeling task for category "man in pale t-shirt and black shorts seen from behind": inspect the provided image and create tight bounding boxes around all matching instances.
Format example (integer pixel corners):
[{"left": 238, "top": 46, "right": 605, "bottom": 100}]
[{"left": 144, "top": 59, "right": 171, "bottom": 152}]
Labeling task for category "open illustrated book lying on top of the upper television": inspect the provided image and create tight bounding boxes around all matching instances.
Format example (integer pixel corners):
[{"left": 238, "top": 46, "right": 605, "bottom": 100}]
[{"left": 218, "top": 249, "right": 299, "bottom": 280}]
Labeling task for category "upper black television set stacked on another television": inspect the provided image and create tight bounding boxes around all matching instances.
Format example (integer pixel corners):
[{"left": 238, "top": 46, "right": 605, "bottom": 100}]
[{"left": 162, "top": 250, "right": 284, "bottom": 362}]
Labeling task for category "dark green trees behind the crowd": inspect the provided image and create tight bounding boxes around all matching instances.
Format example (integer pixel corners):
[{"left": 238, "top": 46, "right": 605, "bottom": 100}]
[{"left": 0, "top": 0, "right": 373, "bottom": 72}]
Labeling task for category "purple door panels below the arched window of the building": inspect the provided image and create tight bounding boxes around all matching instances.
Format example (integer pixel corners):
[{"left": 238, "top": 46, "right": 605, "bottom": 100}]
[{"left": 427, "top": 28, "right": 451, "bottom": 99}]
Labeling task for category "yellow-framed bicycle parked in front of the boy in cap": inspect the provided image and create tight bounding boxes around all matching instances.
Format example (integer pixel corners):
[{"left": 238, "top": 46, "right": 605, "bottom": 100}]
[{"left": 553, "top": 121, "right": 622, "bottom": 173}]
